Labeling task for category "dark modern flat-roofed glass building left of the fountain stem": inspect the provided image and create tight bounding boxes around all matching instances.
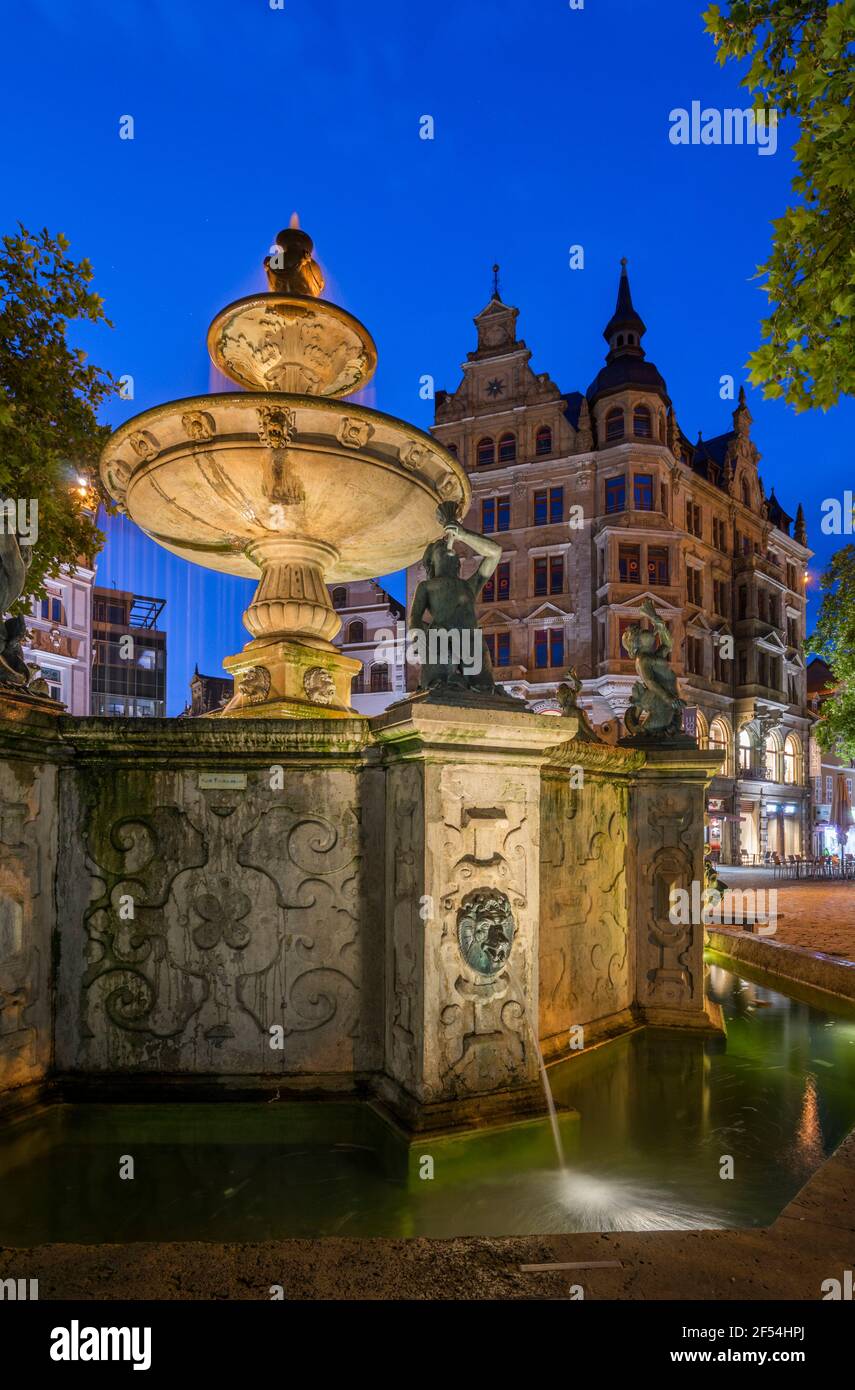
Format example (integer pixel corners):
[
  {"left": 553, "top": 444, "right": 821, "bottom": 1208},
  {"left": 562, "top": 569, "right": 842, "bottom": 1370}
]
[{"left": 92, "top": 588, "right": 167, "bottom": 719}]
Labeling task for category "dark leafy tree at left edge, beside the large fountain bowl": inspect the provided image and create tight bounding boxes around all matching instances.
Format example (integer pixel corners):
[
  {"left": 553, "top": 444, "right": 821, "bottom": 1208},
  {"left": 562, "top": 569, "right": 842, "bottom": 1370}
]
[{"left": 0, "top": 225, "right": 118, "bottom": 607}]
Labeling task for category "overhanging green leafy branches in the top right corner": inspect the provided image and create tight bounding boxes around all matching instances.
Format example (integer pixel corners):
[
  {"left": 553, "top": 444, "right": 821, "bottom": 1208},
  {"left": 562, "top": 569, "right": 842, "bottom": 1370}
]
[{"left": 703, "top": 0, "right": 855, "bottom": 410}]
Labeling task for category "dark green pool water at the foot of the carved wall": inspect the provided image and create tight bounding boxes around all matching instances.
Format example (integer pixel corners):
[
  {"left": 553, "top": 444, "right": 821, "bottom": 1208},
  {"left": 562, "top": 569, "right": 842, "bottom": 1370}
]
[{"left": 0, "top": 965, "right": 855, "bottom": 1244}]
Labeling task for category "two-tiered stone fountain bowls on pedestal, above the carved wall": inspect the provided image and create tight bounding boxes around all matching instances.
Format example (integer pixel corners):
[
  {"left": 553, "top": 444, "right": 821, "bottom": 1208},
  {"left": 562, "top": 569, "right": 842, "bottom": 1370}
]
[{"left": 101, "top": 228, "right": 470, "bottom": 719}]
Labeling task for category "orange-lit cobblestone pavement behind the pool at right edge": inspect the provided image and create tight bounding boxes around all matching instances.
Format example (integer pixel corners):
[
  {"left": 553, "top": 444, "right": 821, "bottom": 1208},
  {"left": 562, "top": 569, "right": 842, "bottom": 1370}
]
[{"left": 719, "top": 865, "right": 855, "bottom": 960}]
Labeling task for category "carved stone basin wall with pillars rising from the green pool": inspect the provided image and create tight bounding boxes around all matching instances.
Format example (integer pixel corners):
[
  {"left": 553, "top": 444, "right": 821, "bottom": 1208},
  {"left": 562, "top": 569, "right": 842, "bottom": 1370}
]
[{"left": 0, "top": 702, "right": 716, "bottom": 1126}]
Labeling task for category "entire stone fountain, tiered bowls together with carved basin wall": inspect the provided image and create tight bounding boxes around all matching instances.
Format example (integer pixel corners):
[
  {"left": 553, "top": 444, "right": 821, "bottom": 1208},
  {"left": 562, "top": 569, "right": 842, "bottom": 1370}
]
[{"left": 0, "top": 228, "right": 720, "bottom": 1131}]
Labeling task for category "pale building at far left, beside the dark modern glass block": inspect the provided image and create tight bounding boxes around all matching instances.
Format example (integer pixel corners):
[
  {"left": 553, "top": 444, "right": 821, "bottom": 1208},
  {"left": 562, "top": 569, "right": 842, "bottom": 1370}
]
[{"left": 22, "top": 562, "right": 95, "bottom": 714}]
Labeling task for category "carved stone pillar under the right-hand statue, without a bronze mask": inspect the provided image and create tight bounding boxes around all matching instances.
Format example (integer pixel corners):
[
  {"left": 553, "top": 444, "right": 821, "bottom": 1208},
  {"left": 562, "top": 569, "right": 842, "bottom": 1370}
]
[{"left": 627, "top": 746, "right": 720, "bottom": 1031}]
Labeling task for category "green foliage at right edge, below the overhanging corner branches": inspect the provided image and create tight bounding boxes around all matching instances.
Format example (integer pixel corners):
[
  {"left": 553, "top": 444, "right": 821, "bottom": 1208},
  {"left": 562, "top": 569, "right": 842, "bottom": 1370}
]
[{"left": 809, "top": 545, "right": 855, "bottom": 758}]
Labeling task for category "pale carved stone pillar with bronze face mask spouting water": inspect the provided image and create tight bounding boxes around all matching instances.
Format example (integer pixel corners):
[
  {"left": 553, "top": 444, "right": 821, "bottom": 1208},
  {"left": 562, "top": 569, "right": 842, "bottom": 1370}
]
[{"left": 371, "top": 699, "right": 569, "bottom": 1129}]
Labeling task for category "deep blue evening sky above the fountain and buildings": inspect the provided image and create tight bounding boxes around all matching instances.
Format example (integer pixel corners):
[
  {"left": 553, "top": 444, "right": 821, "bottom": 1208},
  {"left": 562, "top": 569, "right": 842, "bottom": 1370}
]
[{"left": 0, "top": 0, "right": 855, "bottom": 713}]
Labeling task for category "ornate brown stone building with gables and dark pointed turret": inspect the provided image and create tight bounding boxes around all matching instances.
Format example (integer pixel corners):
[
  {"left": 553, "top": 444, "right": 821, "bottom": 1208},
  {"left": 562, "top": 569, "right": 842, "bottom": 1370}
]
[{"left": 407, "top": 261, "right": 811, "bottom": 862}]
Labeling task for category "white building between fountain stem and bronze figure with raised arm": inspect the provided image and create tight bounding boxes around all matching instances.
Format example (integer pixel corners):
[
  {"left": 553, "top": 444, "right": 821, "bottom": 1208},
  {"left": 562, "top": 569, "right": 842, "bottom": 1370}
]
[{"left": 329, "top": 580, "right": 407, "bottom": 714}]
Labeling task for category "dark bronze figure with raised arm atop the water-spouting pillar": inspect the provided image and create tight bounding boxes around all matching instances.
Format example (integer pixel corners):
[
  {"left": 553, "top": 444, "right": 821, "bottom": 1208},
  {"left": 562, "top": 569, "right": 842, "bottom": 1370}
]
[{"left": 410, "top": 503, "right": 502, "bottom": 694}]
